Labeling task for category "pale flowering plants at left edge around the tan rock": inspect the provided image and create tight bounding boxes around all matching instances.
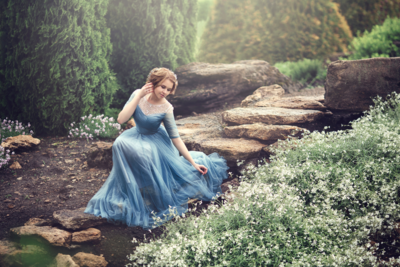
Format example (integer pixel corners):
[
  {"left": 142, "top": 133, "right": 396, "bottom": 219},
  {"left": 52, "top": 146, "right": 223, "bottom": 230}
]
[{"left": 0, "top": 118, "right": 33, "bottom": 169}]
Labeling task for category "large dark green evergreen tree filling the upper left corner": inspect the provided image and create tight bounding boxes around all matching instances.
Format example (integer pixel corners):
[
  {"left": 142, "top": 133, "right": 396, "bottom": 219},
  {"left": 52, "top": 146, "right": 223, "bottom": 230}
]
[{"left": 0, "top": 0, "right": 116, "bottom": 133}]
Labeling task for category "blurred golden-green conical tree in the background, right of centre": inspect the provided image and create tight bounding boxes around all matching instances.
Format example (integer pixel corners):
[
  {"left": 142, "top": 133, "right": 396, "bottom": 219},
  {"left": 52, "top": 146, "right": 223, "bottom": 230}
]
[{"left": 199, "top": 0, "right": 352, "bottom": 64}]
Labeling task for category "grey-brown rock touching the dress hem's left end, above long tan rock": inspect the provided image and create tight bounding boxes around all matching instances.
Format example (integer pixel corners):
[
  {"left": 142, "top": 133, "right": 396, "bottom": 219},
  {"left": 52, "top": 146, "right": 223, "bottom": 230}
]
[{"left": 53, "top": 208, "right": 107, "bottom": 230}]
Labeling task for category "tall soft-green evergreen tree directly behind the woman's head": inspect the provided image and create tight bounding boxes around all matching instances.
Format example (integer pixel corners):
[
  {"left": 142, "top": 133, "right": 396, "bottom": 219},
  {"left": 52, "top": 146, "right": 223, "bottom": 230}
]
[{"left": 107, "top": 0, "right": 197, "bottom": 108}]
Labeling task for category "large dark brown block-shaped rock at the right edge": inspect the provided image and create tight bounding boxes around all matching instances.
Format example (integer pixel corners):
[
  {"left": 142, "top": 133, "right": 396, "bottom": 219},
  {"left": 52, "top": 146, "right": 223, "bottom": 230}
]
[{"left": 325, "top": 57, "right": 400, "bottom": 112}]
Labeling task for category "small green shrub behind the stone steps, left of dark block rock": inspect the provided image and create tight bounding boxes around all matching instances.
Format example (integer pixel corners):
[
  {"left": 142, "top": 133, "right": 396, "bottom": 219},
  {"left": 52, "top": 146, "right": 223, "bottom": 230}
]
[{"left": 274, "top": 59, "right": 327, "bottom": 84}]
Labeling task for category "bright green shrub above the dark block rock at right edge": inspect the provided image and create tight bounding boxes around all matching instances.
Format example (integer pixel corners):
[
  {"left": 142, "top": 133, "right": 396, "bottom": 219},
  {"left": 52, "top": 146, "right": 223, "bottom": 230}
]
[{"left": 348, "top": 18, "right": 400, "bottom": 60}]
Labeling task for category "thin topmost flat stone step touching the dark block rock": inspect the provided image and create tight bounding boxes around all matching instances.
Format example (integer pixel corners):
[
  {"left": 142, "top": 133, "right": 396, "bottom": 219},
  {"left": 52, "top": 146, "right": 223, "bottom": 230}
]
[{"left": 254, "top": 95, "right": 326, "bottom": 110}]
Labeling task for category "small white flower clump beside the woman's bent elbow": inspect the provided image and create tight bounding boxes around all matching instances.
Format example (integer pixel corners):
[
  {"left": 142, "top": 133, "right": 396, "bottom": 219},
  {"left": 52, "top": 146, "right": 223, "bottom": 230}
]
[{"left": 68, "top": 114, "right": 121, "bottom": 140}]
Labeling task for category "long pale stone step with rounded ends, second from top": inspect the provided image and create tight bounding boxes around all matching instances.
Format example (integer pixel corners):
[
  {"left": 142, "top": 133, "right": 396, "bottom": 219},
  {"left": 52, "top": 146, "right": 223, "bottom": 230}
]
[{"left": 222, "top": 107, "right": 324, "bottom": 125}]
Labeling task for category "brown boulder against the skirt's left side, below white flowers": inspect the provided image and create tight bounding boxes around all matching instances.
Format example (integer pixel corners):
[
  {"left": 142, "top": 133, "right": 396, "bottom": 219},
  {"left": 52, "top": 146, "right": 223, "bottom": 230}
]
[{"left": 87, "top": 141, "right": 112, "bottom": 169}]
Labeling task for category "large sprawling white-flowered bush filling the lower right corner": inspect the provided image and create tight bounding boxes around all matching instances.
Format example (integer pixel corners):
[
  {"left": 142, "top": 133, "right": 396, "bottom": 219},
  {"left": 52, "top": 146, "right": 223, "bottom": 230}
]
[{"left": 128, "top": 93, "right": 400, "bottom": 266}]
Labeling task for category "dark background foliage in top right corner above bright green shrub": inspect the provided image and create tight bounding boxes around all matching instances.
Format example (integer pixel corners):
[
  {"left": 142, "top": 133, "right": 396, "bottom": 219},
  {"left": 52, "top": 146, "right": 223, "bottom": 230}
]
[{"left": 333, "top": 0, "right": 400, "bottom": 35}]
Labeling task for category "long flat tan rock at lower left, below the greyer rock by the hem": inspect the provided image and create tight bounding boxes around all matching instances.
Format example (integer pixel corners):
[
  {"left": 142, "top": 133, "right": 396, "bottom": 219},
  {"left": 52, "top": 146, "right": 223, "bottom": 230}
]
[{"left": 10, "top": 226, "right": 72, "bottom": 247}]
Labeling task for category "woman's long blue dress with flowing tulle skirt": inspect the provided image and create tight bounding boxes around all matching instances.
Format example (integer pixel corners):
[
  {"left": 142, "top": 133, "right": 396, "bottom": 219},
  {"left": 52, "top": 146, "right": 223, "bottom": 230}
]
[{"left": 85, "top": 91, "right": 228, "bottom": 229}]
